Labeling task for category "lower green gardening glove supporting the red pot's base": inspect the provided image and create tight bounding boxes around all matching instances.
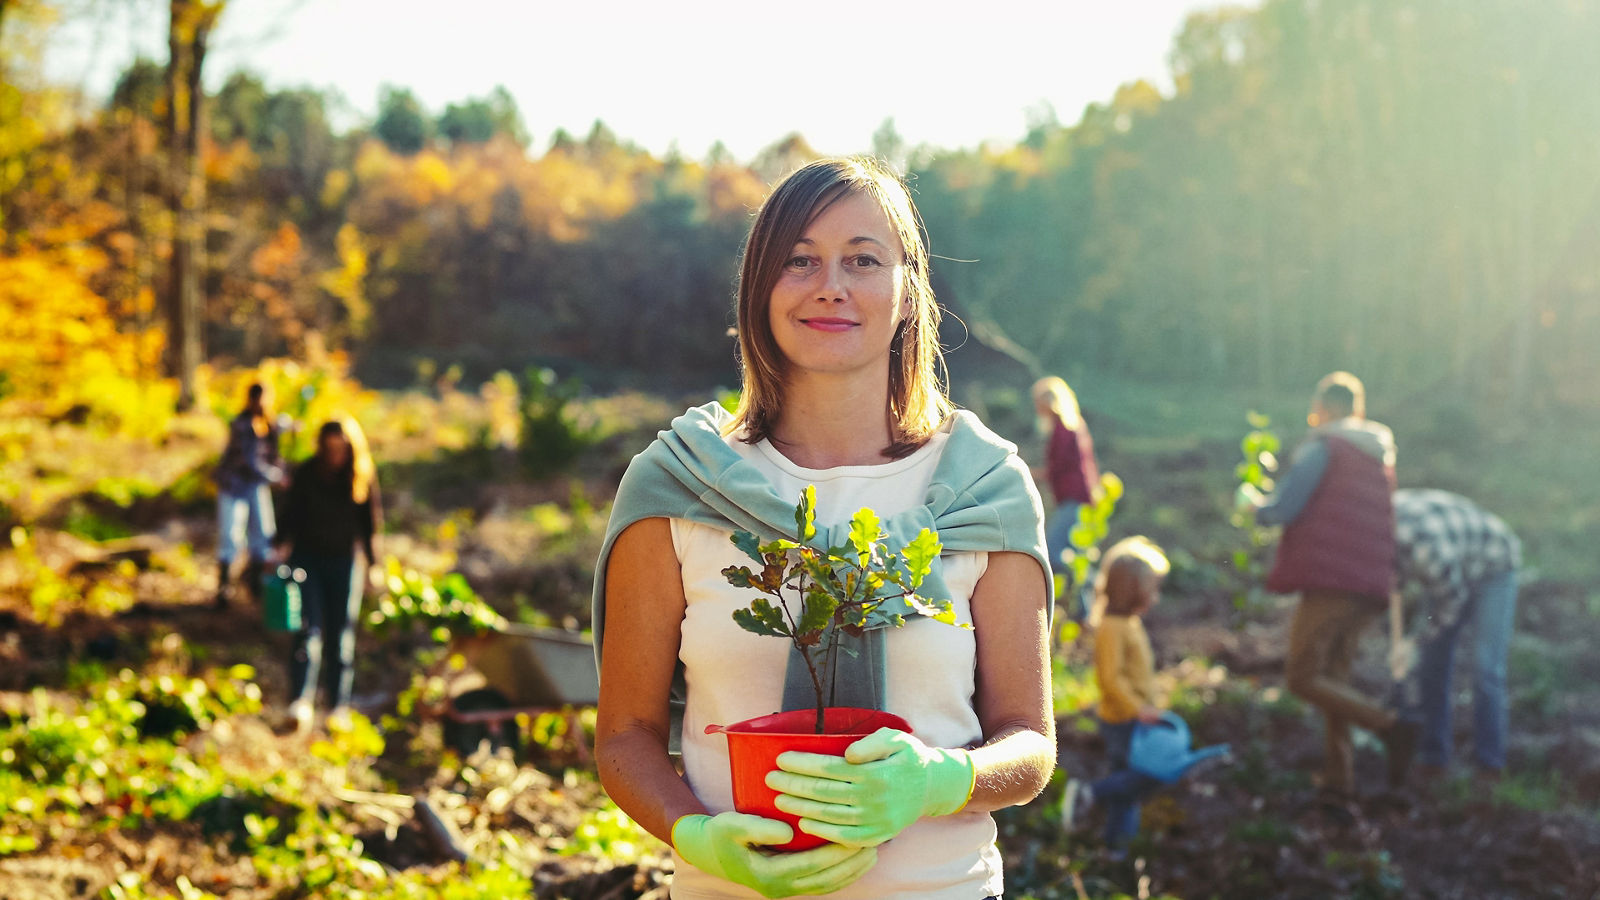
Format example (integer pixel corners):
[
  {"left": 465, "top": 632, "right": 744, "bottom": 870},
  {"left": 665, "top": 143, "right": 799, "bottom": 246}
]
[{"left": 672, "top": 812, "right": 878, "bottom": 897}]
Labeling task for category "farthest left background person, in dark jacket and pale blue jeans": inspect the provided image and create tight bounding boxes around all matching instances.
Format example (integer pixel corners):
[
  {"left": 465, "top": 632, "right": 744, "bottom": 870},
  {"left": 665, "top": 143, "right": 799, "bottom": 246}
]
[{"left": 213, "top": 381, "right": 283, "bottom": 609}]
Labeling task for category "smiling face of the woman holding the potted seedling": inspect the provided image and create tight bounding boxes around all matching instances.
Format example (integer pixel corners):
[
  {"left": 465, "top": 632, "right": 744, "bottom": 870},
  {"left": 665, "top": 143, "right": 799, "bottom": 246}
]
[{"left": 768, "top": 194, "right": 909, "bottom": 373}]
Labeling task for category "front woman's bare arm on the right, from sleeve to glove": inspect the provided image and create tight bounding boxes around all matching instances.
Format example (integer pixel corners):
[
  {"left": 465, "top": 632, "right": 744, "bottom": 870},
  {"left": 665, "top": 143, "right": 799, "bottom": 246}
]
[{"left": 965, "top": 552, "right": 1056, "bottom": 810}]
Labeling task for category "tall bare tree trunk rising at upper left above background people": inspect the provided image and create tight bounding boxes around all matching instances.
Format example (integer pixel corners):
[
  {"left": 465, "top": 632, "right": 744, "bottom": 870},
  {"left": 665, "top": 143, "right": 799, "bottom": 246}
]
[{"left": 165, "top": 0, "right": 222, "bottom": 410}]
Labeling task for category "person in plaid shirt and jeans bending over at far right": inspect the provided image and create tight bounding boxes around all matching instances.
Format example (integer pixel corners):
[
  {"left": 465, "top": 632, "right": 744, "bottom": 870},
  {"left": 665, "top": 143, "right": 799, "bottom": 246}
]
[{"left": 1392, "top": 490, "right": 1522, "bottom": 780}]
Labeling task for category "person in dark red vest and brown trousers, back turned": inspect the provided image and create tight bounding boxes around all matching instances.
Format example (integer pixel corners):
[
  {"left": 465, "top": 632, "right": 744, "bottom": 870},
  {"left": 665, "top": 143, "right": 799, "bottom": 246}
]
[{"left": 1243, "top": 372, "right": 1421, "bottom": 801}]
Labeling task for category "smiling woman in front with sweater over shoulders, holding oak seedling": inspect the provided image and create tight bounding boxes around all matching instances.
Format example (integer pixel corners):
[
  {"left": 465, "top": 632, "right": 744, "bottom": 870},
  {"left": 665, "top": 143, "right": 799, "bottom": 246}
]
[{"left": 595, "top": 160, "right": 1054, "bottom": 900}]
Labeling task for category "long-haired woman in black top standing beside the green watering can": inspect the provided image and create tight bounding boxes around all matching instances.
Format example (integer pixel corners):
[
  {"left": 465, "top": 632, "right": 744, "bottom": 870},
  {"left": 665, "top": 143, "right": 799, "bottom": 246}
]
[{"left": 275, "top": 418, "right": 381, "bottom": 730}]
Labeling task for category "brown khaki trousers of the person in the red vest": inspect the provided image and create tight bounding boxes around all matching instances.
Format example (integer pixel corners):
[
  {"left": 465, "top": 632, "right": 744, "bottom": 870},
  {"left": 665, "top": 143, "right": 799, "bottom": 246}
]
[{"left": 1283, "top": 591, "right": 1395, "bottom": 794}]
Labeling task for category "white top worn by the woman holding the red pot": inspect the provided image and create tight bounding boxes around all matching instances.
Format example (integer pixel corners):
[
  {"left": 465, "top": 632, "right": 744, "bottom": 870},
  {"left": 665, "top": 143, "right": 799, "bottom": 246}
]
[{"left": 670, "top": 432, "right": 1003, "bottom": 900}]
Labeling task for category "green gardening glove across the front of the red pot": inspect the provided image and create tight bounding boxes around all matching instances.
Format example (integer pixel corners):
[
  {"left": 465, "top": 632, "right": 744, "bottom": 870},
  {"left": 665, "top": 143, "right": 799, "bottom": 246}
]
[{"left": 766, "top": 729, "right": 978, "bottom": 847}]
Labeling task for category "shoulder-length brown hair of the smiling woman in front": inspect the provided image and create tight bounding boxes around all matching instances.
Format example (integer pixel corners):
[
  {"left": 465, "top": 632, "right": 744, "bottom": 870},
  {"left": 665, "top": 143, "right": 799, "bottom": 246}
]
[{"left": 728, "top": 159, "right": 950, "bottom": 458}]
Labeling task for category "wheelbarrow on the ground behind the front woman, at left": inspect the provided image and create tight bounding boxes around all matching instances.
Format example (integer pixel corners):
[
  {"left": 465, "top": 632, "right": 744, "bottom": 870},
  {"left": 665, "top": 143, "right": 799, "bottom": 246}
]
[{"left": 434, "top": 620, "right": 600, "bottom": 764}]
